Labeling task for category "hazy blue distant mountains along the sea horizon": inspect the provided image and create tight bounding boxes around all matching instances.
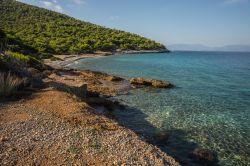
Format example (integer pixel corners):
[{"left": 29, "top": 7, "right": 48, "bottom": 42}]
[{"left": 168, "top": 44, "right": 250, "bottom": 52}]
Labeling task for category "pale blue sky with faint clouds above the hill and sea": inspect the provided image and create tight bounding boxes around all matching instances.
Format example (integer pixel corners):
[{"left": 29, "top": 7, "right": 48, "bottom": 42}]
[{"left": 16, "top": 0, "right": 250, "bottom": 47}]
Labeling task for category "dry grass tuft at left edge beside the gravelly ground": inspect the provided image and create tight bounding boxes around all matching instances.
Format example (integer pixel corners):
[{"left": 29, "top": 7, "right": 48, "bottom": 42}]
[{"left": 0, "top": 72, "right": 23, "bottom": 97}]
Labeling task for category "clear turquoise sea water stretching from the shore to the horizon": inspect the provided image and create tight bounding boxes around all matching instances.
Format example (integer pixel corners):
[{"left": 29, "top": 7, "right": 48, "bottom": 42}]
[{"left": 70, "top": 52, "right": 250, "bottom": 165}]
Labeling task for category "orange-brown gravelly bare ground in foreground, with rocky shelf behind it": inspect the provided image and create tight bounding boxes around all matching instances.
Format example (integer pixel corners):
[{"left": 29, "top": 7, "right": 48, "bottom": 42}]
[{"left": 0, "top": 56, "right": 179, "bottom": 166}]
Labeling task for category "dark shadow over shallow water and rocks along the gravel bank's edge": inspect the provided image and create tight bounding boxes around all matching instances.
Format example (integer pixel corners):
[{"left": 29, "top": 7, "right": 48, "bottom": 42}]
[{"left": 107, "top": 106, "right": 218, "bottom": 166}]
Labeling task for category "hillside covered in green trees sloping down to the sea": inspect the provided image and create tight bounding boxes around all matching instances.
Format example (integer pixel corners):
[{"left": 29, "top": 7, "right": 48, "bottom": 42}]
[{"left": 0, "top": 0, "right": 168, "bottom": 57}]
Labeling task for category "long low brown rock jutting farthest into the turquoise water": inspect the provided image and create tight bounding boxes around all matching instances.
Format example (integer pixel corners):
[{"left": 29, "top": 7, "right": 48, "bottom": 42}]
[{"left": 130, "top": 77, "right": 173, "bottom": 88}]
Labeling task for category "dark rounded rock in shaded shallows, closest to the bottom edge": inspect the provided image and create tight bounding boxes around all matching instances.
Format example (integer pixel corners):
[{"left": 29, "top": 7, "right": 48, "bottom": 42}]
[{"left": 190, "top": 148, "right": 217, "bottom": 165}]
